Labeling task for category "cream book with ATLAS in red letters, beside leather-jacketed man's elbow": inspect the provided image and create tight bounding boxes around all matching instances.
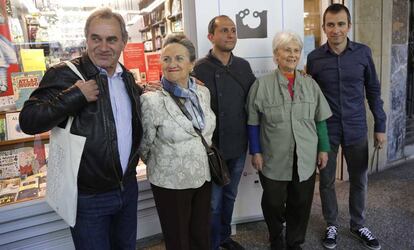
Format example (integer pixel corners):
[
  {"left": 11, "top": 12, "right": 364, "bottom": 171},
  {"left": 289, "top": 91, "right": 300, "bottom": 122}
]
[{"left": 11, "top": 71, "right": 43, "bottom": 110}]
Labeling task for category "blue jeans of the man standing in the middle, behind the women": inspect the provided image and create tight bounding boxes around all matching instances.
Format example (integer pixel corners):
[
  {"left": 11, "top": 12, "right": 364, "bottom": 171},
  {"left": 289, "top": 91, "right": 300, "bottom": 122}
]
[{"left": 211, "top": 155, "right": 246, "bottom": 250}]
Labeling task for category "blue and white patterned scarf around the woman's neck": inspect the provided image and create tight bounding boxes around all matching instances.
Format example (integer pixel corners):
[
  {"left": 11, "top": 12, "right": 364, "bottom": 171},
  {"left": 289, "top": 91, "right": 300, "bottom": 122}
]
[{"left": 161, "top": 77, "right": 205, "bottom": 130}]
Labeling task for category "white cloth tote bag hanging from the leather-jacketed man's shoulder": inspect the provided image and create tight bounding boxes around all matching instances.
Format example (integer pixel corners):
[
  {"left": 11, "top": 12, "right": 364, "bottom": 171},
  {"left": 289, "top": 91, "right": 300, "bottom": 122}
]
[{"left": 46, "top": 62, "right": 86, "bottom": 227}]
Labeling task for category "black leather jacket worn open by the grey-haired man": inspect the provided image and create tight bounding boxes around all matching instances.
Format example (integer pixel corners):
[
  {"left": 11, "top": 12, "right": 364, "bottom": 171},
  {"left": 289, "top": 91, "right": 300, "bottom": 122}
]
[{"left": 20, "top": 55, "right": 142, "bottom": 193}]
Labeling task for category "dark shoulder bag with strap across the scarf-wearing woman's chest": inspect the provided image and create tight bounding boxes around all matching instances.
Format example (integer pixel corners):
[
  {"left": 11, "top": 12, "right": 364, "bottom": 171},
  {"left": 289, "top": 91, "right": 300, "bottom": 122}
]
[{"left": 170, "top": 93, "right": 230, "bottom": 187}]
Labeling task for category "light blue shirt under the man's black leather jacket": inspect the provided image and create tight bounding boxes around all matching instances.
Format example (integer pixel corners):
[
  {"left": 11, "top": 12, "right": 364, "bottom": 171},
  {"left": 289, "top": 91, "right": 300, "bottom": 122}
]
[{"left": 99, "top": 64, "right": 132, "bottom": 173}]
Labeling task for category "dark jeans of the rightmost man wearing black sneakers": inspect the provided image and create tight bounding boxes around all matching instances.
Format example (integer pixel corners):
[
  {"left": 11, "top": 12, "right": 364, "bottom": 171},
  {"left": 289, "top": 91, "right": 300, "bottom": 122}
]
[{"left": 319, "top": 138, "right": 368, "bottom": 229}]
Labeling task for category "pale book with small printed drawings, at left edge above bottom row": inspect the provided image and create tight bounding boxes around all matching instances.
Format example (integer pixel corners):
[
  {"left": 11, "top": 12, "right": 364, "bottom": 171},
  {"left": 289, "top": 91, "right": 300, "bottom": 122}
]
[{"left": 0, "top": 149, "right": 20, "bottom": 179}]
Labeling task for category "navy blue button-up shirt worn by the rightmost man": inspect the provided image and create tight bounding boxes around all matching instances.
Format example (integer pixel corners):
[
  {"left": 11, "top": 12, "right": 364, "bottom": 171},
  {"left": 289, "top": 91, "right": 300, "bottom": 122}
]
[{"left": 306, "top": 39, "right": 386, "bottom": 146}]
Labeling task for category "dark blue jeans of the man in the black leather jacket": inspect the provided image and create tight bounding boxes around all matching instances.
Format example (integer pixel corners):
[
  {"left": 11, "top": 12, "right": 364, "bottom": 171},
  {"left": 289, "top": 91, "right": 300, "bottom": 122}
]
[{"left": 70, "top": 181, "right": 138, "bottom": 250}]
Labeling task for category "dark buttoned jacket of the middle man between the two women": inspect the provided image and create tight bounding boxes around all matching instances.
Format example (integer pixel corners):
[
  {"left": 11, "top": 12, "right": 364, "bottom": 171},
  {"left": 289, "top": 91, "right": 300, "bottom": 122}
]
[{"left": 194, "top": 51, "right": 256, "bottom": 159}]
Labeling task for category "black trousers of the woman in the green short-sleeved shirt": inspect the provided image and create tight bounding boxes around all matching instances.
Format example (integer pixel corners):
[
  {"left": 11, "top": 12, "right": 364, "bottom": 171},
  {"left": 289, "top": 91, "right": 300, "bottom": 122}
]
[{"left": 259, "top": 157, "right": 315, "bottom": 249}]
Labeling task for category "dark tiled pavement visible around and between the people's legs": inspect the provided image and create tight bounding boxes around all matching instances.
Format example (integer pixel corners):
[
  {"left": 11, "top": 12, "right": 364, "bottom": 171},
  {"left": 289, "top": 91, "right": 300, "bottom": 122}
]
[{"left": 137, "top": 161, "right": 414, "bottom": 250}]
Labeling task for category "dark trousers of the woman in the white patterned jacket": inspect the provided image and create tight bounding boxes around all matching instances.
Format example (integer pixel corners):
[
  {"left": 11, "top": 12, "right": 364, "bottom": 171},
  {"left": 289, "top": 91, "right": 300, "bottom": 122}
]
[{"left": 151, "top": 182, "right": 211, "bottom": 250}]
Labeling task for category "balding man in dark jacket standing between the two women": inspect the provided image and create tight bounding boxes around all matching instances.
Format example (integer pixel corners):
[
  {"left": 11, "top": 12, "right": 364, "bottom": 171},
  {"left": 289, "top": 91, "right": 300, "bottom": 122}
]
[{"left": 194, "top": 16, "right": 256, "bottom": 250}]
